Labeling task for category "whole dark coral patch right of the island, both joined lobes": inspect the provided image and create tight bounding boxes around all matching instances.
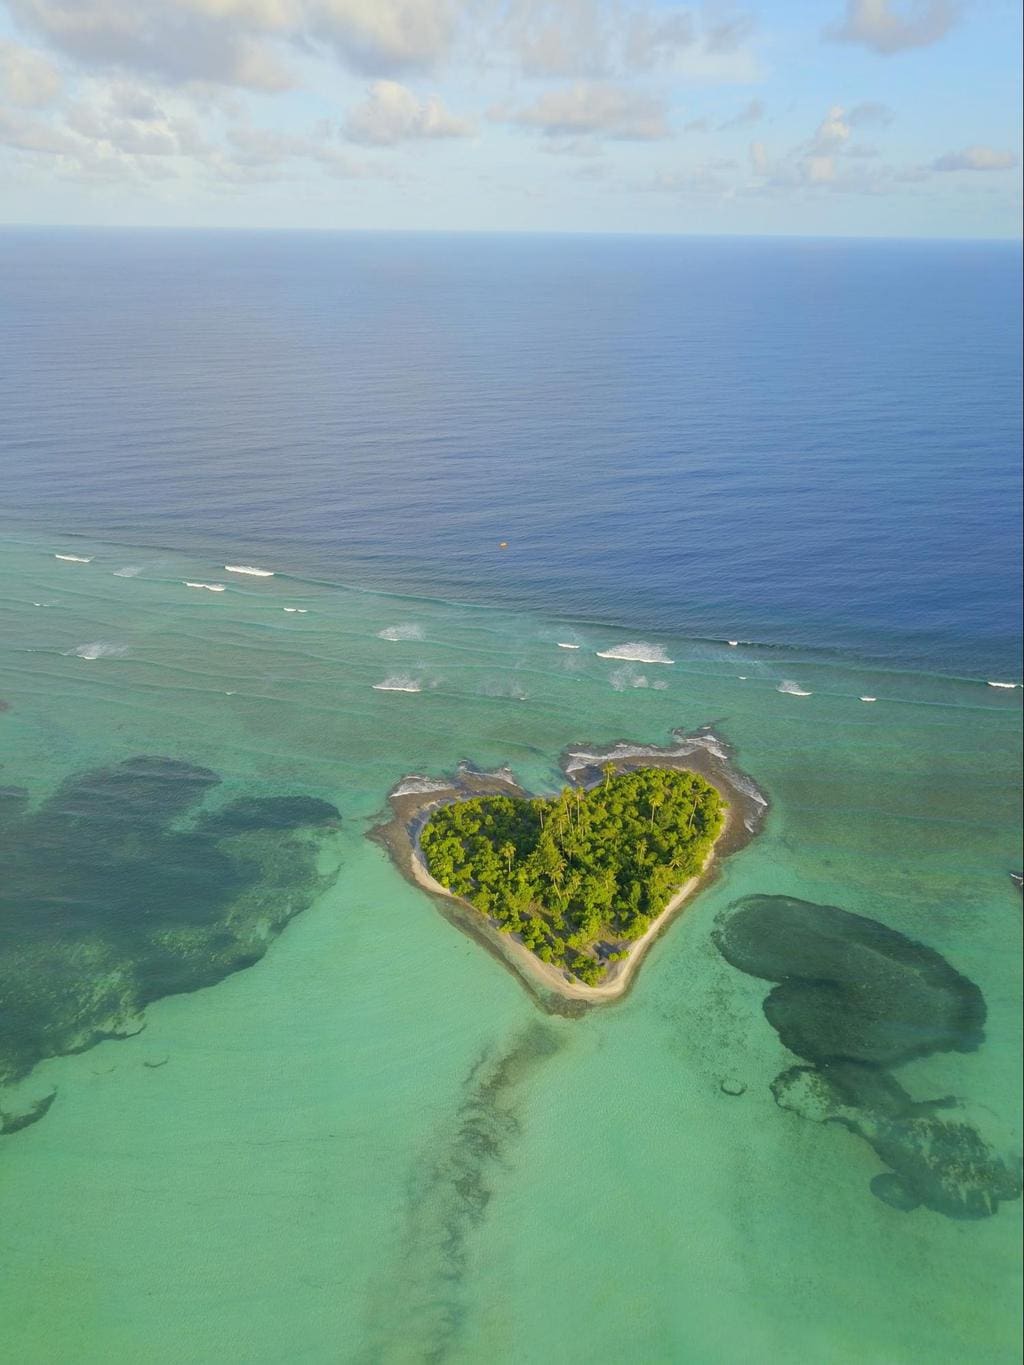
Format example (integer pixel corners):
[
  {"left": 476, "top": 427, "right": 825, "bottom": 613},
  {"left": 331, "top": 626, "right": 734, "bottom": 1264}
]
[{"left": 713, "top": 895, "right": 1021, "bottom": 1219}]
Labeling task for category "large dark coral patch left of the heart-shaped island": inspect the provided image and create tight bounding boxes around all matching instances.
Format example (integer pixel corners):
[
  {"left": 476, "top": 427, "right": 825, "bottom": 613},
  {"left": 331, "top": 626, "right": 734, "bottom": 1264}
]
[{"left": 0, "top": 758, "right": 345, "bottom": 1124}]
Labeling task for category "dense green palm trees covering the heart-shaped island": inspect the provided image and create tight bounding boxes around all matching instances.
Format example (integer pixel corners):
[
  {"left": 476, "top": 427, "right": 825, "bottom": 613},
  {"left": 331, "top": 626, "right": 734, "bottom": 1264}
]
[{"left": 421, "top": 763, "right": 725, "bottom": 986}]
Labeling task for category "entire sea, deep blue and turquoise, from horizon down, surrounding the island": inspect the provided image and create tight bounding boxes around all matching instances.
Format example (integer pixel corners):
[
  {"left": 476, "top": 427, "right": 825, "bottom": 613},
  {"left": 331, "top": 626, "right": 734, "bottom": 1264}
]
[{"left": 0, "top": 235, "right": 1024, "bottom": 1365}]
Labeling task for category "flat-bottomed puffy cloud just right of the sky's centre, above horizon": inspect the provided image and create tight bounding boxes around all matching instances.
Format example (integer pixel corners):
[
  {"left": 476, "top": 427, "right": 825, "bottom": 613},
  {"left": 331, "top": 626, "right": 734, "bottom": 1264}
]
[{"left": 492, "top": 81, "right": 669, "bottom": 142}]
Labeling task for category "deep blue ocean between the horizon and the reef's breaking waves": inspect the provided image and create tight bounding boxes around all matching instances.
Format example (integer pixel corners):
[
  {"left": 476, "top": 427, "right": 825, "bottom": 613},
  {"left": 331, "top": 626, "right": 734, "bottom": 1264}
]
[{"left": 0, "top": 231, "right": 1021, "bottom": 677}]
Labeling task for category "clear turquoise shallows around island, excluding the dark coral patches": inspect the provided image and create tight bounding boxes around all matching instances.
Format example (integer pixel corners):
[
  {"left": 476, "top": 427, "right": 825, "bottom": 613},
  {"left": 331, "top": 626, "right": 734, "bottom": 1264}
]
[{"left": 0, "top": 530, "right": 1023, "bottom": 1365}]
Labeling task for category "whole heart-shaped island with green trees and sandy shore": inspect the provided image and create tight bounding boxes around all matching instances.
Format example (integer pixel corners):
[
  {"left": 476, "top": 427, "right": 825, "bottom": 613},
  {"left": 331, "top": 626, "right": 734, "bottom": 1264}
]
[{"left": 371, "top": 732, "right": 767, "bottom": 1013}]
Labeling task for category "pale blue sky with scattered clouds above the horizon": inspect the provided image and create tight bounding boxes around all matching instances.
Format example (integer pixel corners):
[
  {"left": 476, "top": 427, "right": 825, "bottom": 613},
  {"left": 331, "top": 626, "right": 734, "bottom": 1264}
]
[{"left": 0, "top": 0, "right": 1021, "bottom": 238}]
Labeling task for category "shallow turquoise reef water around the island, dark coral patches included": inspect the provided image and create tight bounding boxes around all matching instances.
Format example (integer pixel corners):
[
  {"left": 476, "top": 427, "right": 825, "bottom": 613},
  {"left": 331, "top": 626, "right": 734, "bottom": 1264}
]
[{"left": 0, "top": 534, "right": 1024, "bottom": 1365}]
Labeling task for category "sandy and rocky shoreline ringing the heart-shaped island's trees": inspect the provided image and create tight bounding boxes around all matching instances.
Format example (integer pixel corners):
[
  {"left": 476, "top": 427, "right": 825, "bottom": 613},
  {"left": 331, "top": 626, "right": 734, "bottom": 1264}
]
[{"left": 370, "top": 728, "right": 767, "bottom": 1014}]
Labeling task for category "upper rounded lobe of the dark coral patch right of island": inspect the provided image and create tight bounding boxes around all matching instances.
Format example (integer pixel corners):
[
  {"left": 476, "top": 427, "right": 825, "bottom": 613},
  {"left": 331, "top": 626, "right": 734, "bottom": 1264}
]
[{"left": 714, "top": 895, "right": 984, "bottom": 1066}]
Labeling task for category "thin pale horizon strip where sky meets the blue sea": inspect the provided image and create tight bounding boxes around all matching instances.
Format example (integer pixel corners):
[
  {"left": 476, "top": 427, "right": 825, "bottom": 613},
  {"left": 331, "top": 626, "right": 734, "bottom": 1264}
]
[{"left": 0, "top": 221, "right": 1024, "bottom": 247}]
